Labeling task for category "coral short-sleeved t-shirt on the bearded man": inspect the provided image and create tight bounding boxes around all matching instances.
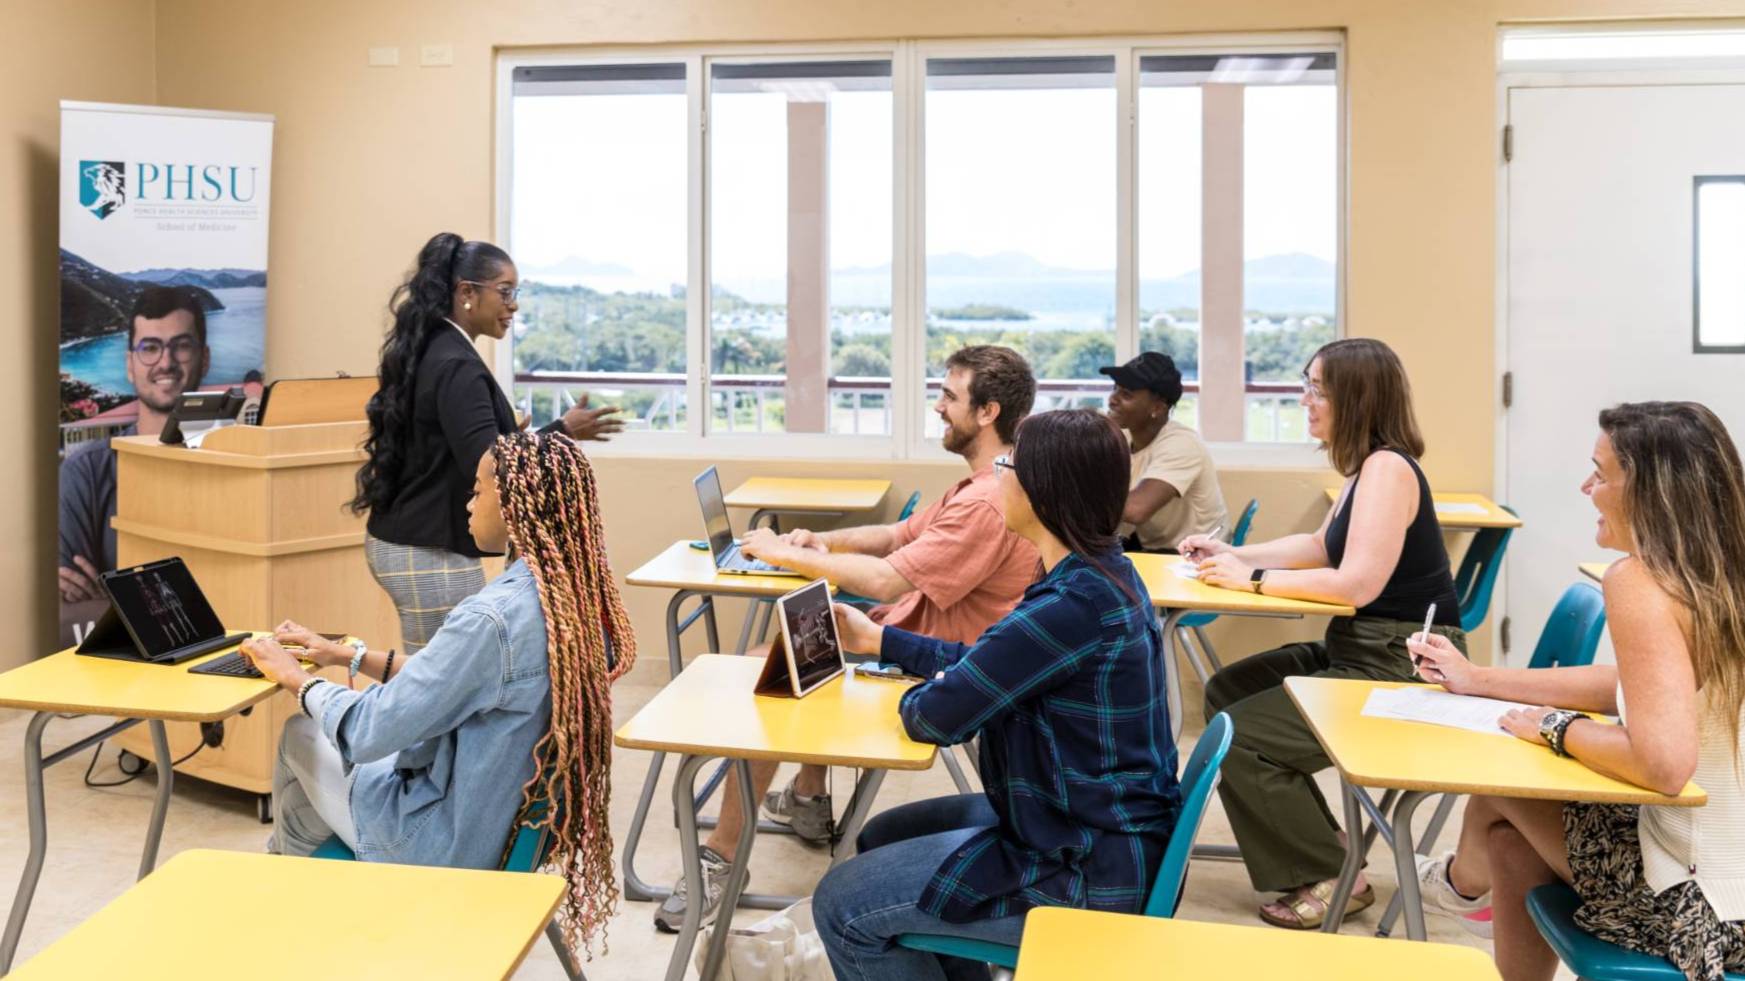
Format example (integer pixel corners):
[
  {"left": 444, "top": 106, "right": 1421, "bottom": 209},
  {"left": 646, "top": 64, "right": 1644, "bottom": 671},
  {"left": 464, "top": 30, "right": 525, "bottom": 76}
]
[{"left": 871, "top": 466, "right": 1040, "bottom": 644}]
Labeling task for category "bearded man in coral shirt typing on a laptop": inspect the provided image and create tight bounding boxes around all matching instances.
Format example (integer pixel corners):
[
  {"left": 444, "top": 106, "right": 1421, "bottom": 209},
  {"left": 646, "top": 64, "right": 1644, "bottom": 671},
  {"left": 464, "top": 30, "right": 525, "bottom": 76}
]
[{"left": 654, "top": 344, "right": 1040, "bottom": 932}]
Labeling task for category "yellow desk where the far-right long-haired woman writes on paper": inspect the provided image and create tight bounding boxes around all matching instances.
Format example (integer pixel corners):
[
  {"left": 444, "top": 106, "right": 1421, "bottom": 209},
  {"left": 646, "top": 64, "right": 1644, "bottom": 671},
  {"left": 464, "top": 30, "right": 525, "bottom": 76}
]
[{"left": 1284, "top": 677, "right": 1708, "bottom": 941}]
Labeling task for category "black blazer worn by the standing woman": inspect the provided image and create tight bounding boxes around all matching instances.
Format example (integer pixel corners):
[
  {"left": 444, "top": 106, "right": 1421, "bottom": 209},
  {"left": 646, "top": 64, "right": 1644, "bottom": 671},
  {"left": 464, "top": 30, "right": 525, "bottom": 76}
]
[{"left": 368, "top": 321, "right": 515, "bottom": 557}]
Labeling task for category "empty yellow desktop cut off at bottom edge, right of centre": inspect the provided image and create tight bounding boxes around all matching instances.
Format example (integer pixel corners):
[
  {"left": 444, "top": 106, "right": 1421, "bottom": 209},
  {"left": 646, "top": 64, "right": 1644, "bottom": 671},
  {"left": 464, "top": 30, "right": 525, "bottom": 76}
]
[{"left": 1017, "top": 906, "right": 1499, "bottom": 981}]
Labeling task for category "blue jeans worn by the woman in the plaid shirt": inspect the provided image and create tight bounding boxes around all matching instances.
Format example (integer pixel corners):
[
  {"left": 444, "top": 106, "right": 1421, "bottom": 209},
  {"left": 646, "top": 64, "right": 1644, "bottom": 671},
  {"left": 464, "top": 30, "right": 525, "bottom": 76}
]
[{"left": 811, "top": 794, "right": 1024, "bottom": 981}]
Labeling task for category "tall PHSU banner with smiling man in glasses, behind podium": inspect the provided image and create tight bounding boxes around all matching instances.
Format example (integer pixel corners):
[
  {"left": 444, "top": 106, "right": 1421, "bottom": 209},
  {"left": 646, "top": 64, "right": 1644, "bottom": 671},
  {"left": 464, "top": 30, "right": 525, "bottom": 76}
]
[{"left": 58, "top": 101, "right": 272, "bottom": 642}]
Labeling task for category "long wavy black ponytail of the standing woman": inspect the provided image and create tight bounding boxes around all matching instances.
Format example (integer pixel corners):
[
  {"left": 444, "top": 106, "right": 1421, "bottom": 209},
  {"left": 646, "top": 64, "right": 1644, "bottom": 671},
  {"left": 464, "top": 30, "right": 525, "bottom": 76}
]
[{"left": 351, "top": 232, "right": 510, "bottom": 515}]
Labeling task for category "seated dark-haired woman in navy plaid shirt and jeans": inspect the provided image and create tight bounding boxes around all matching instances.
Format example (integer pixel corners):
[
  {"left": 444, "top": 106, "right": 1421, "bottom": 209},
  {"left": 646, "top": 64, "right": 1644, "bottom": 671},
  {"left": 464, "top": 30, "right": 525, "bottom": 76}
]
[{"left": 813, "top": 410, "right": 1181, "bottom": 981}]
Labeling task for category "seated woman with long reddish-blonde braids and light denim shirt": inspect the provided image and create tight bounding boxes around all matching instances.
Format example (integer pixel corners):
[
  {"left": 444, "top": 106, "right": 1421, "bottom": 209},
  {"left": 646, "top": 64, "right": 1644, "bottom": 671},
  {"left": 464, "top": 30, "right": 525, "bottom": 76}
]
[{"left": 243, "top": 433, "right": 635, "bottom": 950}]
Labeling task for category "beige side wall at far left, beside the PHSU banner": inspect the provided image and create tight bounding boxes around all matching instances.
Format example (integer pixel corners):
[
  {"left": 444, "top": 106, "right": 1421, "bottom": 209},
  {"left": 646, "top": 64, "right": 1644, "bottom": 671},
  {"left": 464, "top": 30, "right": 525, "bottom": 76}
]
[{"left": 0, "top": 0, "right": 155, "bottom": 669}]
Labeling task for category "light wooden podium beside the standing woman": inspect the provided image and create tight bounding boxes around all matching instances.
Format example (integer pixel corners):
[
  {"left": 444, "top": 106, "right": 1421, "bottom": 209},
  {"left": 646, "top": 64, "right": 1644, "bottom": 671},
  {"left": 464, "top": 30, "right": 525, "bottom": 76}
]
[{"left": 113, "top": 418, "right": 400, "bottom": 819}]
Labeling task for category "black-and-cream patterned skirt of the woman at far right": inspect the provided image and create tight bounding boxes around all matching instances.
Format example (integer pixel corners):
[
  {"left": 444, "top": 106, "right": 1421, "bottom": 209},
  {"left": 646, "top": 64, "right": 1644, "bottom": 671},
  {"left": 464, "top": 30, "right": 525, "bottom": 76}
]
[{"left": 1564, "top": 803, "right": 1745, "bottom": 981}]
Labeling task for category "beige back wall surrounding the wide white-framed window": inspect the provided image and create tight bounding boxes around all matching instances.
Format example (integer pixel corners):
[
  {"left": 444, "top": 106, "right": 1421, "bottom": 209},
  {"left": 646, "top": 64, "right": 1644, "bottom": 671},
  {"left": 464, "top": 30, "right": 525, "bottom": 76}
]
[{"left": 7, "top": 0, "right": 1745, "bottom": 653}]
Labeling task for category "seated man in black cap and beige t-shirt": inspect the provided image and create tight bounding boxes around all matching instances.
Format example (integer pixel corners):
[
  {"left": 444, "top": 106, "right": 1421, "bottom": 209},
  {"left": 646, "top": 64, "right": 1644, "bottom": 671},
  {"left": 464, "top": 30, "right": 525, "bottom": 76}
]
[{"left": 1099, "top": 351, "right": 1228, "bottom": 552}]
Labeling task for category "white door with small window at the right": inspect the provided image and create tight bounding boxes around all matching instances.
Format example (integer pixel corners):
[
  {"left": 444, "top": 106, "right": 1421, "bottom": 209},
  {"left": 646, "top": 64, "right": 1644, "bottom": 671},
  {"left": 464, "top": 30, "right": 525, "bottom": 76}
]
[{"left": 1504, "top": 84, "right": 1745, "bottom": 665}]
